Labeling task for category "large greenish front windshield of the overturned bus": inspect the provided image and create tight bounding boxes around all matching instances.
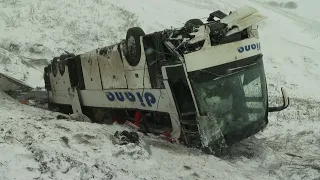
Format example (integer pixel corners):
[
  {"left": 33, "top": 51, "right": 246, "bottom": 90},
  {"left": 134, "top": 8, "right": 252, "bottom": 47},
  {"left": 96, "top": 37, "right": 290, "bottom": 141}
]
[{"left": 189, "top": 56, "right": 267, "bottom": 146}]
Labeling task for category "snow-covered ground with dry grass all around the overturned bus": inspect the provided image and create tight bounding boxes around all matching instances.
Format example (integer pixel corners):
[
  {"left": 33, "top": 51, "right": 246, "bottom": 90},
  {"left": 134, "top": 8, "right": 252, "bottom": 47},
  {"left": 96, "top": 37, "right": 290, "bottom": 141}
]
[{"left": 0, "top": 0, "right": 320, "bottom": 179}]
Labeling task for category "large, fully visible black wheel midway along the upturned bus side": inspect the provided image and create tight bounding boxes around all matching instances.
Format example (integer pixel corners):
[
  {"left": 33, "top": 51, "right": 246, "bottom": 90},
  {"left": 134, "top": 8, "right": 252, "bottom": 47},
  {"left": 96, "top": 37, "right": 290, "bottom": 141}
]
[{"left": 125, "top": 27, "right": 145, "bottom": 66}]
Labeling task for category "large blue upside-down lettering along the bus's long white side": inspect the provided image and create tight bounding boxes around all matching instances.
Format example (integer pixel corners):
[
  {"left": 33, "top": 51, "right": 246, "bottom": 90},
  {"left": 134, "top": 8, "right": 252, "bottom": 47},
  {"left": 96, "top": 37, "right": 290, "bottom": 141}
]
[{"left": 106, "top": 92, "right": 157, "bottom": 107}]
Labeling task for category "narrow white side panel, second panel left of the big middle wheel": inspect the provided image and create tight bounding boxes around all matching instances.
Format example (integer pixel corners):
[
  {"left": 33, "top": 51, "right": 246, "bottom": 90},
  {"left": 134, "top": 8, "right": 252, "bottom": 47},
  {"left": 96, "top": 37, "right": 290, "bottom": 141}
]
[{"left": 80, "top": 51, "right": 102, "bottom": 90}]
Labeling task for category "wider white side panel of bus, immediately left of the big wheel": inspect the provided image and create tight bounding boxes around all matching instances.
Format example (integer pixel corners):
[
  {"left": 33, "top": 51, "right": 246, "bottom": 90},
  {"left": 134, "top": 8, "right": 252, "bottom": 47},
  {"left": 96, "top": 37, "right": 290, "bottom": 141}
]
[{"left": 96, "top": 45, "right": 128, "bottom": 89}]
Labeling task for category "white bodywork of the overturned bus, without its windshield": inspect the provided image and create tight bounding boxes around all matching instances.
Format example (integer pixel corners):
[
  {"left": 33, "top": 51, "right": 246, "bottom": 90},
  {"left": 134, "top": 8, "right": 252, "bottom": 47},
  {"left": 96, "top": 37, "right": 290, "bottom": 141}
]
[{"left": 44, "top": 6, "right": 288, "bottom": 154}]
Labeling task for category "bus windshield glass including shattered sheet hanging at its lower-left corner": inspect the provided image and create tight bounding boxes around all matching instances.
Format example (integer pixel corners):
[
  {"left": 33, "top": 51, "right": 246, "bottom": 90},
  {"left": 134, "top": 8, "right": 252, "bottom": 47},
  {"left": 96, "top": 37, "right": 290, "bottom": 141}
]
[{"left": 191, "top": 58, "right": 267, "bottom": 151}]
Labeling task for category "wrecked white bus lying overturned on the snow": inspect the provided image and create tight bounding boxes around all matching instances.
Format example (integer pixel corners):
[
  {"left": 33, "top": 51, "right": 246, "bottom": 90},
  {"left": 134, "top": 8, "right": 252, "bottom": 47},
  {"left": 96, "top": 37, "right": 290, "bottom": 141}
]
[{"left": 44, "top": 6, "right": 289, "bottom": 153}]
